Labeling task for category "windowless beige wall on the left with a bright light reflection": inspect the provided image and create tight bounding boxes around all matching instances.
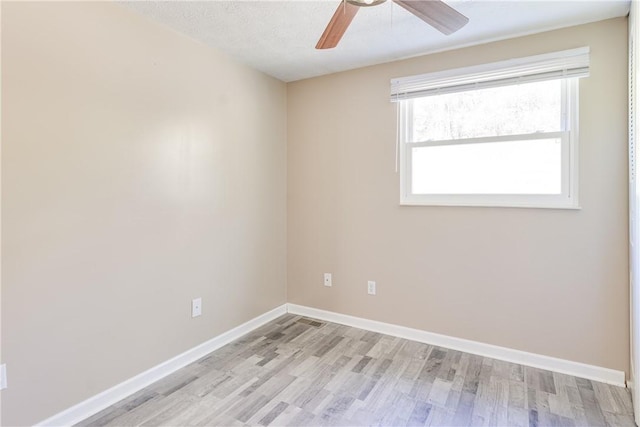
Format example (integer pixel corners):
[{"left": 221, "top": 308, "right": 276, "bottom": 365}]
[{"left": 2, "top": 2, "right": 286, "bottom": 425}]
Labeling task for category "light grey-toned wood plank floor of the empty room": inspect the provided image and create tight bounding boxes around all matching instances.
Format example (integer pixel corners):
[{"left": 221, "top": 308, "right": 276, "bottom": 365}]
[{"left": 80, "top": 315, "right": 635, "bottom": 426}]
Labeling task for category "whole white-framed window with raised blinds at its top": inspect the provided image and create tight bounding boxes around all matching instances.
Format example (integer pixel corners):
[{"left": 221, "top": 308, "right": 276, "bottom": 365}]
[{"left": 391, "top": 48, "right": 589, "bottom": 208}]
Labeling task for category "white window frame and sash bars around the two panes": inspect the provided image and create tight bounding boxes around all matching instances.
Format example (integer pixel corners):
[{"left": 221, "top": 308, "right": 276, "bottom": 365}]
[{"left": 392, "top": 48, "right": 588, "bottom": 209}]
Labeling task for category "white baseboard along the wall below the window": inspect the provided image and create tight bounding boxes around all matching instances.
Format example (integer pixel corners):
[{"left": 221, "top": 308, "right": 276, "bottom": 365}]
[{"left": 287, "top": 304, "right": 625, "bottom": 387}]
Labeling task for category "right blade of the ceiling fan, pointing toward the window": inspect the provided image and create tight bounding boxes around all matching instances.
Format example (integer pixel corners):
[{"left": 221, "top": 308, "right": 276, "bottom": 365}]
[{"left": 393, "top": 0, "right": 469, "bottom": 35}]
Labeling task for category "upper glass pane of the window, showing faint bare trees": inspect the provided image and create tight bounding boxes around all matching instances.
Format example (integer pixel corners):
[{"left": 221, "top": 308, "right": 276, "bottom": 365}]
[{"left": 410, "top": 80, "right": 565, "bottom": 142}]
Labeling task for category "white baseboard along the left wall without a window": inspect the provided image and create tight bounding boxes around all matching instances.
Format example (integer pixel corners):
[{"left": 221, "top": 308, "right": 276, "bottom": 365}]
[{"left": 36, "top": 304, "right": 287, "bottom": 426}]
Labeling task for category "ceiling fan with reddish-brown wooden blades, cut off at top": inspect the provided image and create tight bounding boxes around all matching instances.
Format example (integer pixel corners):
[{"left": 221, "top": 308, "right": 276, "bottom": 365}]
[{"left": 316, "top": 0, "right": 469, "bottom": 49}]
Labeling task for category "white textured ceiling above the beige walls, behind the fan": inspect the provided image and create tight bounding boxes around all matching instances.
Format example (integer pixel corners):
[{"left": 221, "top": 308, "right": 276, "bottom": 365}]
[{"left": 123, "top": 0, "right": 630, "bottom": 82}]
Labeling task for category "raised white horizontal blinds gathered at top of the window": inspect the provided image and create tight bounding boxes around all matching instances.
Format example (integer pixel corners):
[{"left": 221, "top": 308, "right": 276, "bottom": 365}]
[{"left": 391, "top": 47, "right": 589, "bottom": 102}]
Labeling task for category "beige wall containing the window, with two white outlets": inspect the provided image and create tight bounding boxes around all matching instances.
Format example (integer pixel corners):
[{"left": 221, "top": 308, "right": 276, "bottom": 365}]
[{"left": 287, "top": 18, "right": 629, "bottom": 371}]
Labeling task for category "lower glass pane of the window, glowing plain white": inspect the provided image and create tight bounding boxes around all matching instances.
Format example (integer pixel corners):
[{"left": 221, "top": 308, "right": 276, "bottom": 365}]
[{"left": 411, "top": 138, "right": 562, "bottom": 194}]
